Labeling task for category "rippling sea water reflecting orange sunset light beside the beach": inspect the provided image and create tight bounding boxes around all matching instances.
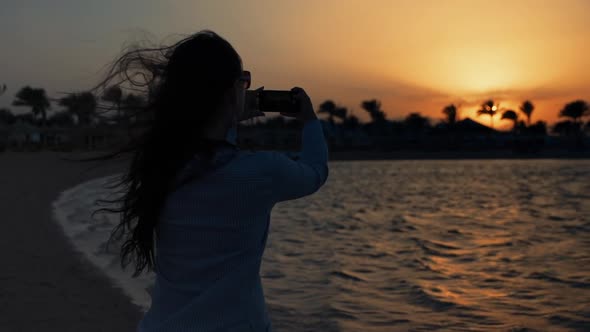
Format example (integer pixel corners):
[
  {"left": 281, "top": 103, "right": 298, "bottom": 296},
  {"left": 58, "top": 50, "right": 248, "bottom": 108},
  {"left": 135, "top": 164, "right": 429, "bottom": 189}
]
[{"left": 54, "top": 160, "right": 590, "bottom": 332}]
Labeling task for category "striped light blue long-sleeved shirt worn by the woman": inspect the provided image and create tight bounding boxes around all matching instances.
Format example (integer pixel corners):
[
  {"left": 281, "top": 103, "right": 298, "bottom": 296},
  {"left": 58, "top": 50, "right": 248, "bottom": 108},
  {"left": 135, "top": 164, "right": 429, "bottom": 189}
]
[{"left": 138, "top": 120, "right": 328, "bottom": 332}]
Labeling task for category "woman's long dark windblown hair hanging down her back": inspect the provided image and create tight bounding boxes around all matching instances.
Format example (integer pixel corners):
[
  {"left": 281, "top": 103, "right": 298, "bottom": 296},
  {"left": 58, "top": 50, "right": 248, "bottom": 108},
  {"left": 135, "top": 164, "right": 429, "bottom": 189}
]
[{"left": 85, "top": 30, "right": 242, "bottom": 277}]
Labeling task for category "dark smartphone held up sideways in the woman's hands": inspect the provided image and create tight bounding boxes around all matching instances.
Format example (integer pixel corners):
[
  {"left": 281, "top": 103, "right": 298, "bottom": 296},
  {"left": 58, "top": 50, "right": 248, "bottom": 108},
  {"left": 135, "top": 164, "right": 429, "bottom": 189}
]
[{"left": 246, "top": 88, "right": 299, "bottom": 113}]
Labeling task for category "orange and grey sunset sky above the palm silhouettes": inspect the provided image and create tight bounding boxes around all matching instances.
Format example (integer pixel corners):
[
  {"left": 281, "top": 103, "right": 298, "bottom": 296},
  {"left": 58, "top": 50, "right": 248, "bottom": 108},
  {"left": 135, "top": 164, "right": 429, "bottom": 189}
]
[{"left": 0, "top": 0, "right": 590, "bottom": 127}]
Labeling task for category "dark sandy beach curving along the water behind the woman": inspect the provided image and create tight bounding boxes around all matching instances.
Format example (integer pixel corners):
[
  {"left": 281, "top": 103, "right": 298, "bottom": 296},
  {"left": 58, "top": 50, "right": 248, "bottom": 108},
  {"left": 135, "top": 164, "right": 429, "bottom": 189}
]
[{"left": 0, "top": 152, "right": 141, "bottom": 331}]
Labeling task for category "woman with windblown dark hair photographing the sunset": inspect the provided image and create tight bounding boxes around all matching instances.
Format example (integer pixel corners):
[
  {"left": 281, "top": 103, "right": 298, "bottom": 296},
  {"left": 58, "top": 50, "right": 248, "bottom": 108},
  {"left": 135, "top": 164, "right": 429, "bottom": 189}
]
[{"left": 91, "top": 31, "right": 328, "bottom": 332}]
